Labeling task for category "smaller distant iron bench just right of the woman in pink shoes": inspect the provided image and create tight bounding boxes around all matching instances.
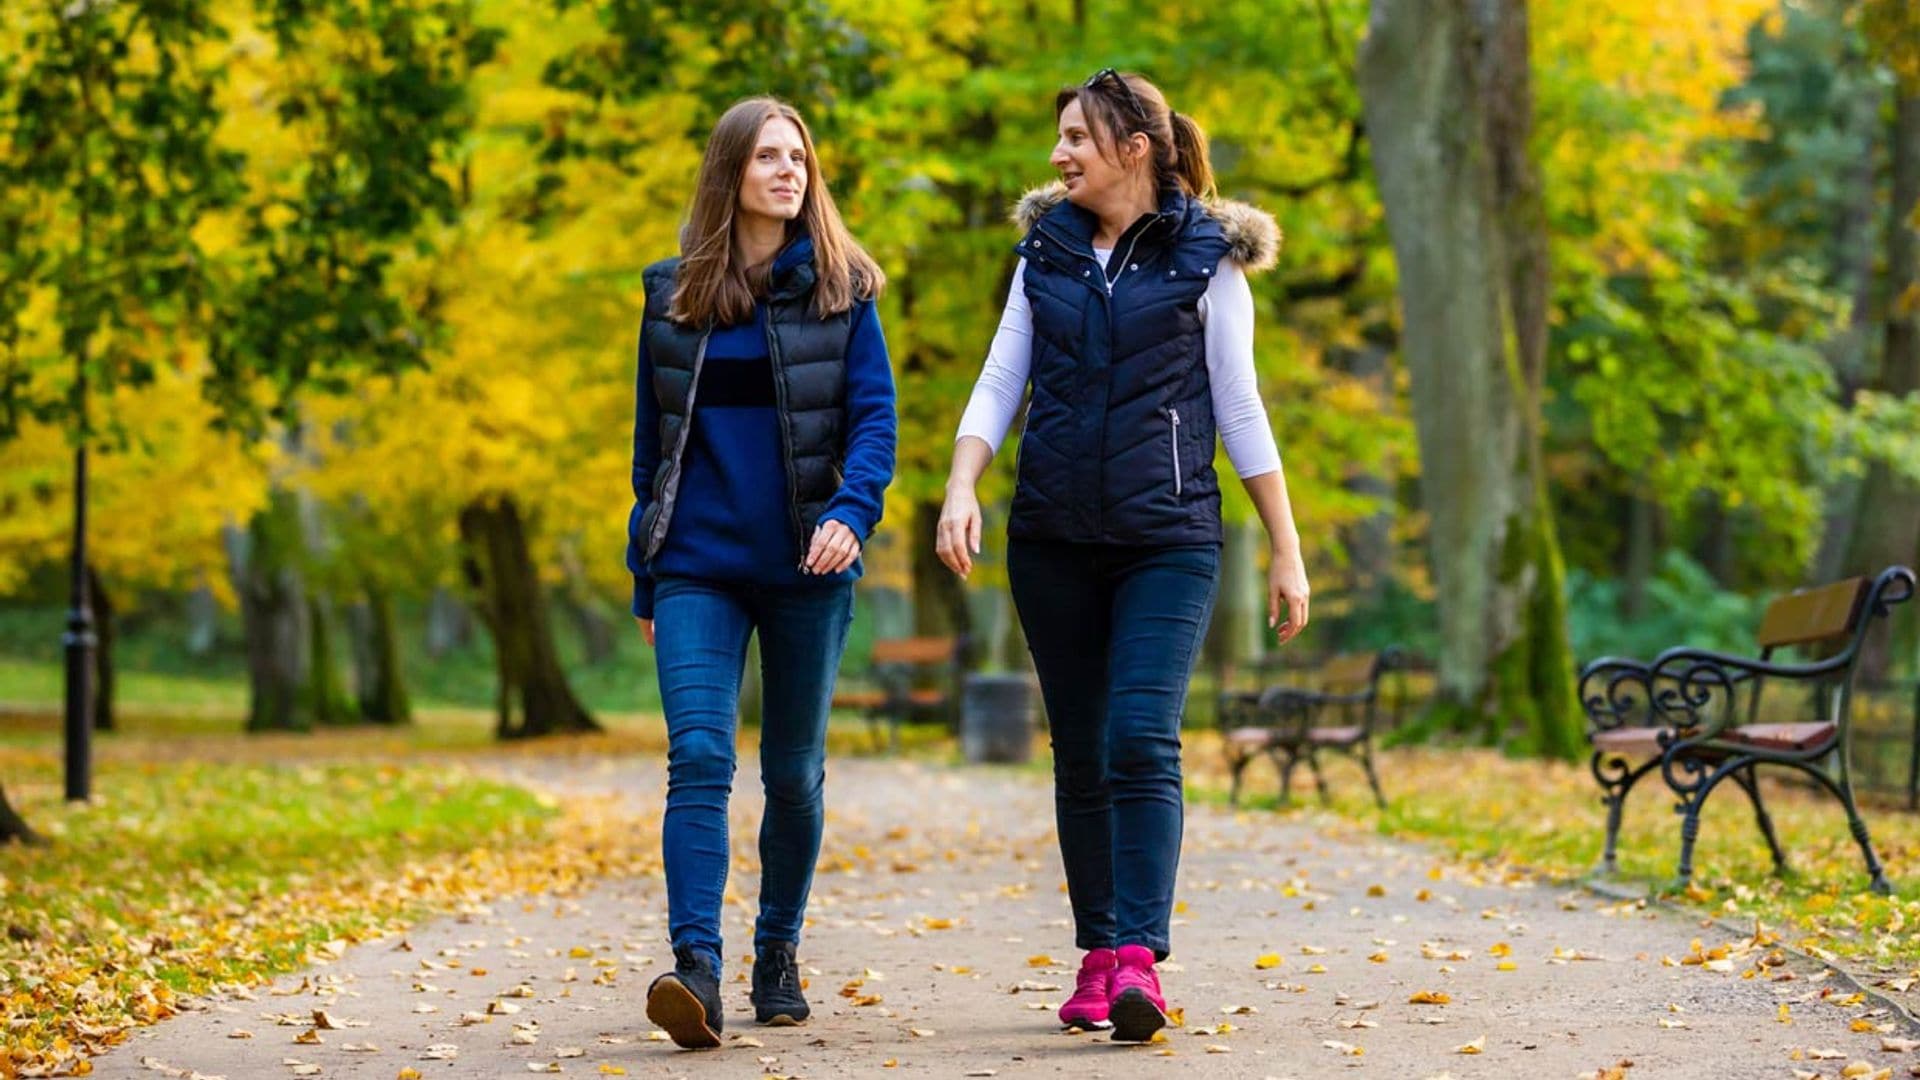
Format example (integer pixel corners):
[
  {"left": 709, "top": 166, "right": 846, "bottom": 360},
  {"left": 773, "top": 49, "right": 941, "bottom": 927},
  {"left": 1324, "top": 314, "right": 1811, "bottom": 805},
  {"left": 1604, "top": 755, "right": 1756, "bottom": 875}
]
[{"left": 1219, "top": 648, "right": 1404, "bottom": 809}]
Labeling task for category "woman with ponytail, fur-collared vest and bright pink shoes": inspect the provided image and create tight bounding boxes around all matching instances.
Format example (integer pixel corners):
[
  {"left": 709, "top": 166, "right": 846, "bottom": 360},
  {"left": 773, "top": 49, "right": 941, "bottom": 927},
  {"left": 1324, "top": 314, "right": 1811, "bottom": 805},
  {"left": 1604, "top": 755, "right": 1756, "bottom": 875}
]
[{"left": 937, "top": 69, "right": 1308, "bottom": 1042}]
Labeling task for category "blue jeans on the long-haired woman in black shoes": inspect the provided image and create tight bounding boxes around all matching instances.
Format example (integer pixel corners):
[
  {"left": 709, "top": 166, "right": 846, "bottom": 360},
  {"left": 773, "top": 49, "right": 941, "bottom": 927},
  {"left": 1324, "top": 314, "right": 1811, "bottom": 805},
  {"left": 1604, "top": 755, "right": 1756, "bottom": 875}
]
[{"left": 653, "top": 577, "right": 852, "bottom": 965}]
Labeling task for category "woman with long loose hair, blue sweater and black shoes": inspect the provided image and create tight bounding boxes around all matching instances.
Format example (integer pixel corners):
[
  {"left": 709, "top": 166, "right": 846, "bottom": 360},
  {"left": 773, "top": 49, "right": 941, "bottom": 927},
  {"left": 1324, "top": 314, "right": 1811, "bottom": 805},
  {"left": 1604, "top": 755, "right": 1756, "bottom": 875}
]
[{"left": 626, "top": 98, "right": 897, "bottom": 1047}]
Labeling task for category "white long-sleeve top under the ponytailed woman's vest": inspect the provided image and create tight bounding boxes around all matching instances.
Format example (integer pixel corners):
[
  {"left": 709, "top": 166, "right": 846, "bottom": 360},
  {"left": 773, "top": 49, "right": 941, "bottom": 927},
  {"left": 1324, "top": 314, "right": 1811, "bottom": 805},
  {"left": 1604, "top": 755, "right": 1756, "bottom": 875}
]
[{"left": 954, "top": 248, "right": 1281, "bottom": 480}]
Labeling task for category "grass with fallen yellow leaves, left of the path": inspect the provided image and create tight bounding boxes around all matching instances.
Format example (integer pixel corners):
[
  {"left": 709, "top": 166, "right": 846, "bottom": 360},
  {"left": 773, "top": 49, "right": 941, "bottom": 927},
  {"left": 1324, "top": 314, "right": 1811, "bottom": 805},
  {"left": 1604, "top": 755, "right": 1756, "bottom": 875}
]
[{"left": 0, "top": 740, "right": 659, "bottom": 1076}]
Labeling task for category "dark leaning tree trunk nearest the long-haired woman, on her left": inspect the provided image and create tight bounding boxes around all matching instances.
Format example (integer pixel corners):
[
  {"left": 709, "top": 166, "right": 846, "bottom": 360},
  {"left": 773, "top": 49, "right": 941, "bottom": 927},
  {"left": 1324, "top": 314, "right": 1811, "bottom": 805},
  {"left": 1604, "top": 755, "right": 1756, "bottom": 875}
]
[{"left": 461, "top": 498, "right": 601, "bottom": 738}]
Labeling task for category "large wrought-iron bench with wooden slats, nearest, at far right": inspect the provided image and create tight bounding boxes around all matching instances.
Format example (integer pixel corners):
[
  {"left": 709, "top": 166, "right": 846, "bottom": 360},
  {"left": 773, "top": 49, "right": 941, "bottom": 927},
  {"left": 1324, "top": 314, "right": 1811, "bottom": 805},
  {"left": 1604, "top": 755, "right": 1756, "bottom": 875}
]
[{"left": 1580, "top": 567, "right": 1914, "bottom": 894}]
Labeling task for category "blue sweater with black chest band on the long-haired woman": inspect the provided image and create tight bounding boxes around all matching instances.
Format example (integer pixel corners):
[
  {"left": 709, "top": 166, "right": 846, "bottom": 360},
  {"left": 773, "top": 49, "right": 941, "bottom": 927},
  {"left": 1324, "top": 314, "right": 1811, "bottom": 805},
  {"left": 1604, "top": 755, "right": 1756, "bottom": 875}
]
[{"left": 626, "top": 282, "right": 897, "bottom": 619}]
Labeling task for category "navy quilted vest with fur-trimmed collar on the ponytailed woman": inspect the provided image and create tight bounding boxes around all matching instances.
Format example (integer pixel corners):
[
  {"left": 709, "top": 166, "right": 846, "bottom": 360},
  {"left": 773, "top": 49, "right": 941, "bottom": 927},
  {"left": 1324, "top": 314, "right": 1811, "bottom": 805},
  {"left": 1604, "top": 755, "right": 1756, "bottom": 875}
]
[{"left": 1006, "top": 192, "right": 1233, "bottom": 546}]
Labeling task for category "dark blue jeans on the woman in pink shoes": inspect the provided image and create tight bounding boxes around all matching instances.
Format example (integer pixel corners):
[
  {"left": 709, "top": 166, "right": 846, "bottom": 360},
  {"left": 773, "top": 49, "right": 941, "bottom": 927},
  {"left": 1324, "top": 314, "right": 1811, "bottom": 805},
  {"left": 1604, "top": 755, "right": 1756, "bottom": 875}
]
[{"left": 1006, "top": 540, "right": 1219, "bottom": 959}]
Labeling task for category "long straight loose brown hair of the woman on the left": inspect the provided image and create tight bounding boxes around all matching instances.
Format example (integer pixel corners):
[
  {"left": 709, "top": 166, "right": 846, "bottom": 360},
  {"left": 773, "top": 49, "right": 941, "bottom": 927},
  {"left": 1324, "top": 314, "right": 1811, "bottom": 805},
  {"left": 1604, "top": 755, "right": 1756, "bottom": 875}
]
[{"left": 668, "top": 98, "right": 887, "bottom": 325}]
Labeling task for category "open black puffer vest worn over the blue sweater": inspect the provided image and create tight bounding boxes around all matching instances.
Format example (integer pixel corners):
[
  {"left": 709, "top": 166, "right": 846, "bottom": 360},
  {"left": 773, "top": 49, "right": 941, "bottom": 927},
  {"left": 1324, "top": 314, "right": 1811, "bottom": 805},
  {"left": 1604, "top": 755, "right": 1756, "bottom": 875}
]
[{"left": 639, "top": 236, "right": 852, "bottom": 561}]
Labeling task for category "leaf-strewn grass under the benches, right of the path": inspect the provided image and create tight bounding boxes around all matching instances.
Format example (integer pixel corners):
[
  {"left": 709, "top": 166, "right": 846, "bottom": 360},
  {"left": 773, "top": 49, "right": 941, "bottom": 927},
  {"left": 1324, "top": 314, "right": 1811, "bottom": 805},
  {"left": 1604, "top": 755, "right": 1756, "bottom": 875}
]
[{"left": 1187, "top": 732, "right": 1920, "bottom": 972}]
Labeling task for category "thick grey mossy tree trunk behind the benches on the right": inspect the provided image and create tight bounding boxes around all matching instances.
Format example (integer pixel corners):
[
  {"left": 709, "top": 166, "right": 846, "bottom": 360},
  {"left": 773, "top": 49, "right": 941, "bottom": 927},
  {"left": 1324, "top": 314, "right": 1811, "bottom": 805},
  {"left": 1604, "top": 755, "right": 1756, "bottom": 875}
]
[{"left": 1359, "top": 0, "right": 1580, "bottom": 757}]
